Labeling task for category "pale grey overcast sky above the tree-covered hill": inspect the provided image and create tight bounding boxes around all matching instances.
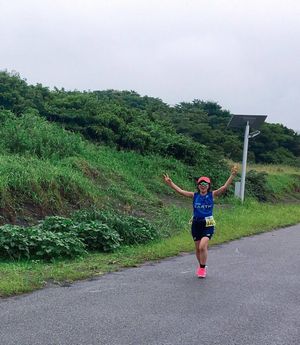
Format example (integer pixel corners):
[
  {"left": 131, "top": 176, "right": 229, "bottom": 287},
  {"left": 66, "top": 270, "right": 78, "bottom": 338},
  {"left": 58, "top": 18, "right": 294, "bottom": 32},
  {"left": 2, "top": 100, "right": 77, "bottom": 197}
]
[{"left": 0, "top": 0, "right": 300, "bottom": 130}]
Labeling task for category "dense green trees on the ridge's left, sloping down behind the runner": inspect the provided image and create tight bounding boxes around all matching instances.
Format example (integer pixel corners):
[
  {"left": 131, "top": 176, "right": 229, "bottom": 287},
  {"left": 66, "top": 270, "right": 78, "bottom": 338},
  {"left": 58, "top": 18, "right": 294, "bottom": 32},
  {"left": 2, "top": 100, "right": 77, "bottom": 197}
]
[{"left": 0, "top": 72, "right": 207, "bottom": 164}]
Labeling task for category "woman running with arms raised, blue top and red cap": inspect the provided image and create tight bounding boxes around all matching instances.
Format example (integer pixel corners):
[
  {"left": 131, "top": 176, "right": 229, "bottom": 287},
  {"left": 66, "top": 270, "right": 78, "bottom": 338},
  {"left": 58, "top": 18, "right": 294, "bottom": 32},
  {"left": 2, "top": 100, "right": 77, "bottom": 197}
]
[{"left": 164, "top": 166, "right": 238, "bottom": 278}]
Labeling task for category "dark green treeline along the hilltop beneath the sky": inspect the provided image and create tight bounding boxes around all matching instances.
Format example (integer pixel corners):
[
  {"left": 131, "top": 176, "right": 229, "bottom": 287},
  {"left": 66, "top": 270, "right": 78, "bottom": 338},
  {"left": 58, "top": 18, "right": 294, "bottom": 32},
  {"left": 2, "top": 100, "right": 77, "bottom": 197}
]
[{"left": 0, "top": 71, "right": 300, "bottom": 166}]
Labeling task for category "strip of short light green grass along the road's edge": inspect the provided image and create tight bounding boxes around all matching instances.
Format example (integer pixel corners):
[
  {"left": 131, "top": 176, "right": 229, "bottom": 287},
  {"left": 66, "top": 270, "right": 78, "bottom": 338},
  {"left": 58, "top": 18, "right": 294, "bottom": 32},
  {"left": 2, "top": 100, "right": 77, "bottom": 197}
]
[{"left": 0, "top": 201, "right": 300, "bottom": 296}]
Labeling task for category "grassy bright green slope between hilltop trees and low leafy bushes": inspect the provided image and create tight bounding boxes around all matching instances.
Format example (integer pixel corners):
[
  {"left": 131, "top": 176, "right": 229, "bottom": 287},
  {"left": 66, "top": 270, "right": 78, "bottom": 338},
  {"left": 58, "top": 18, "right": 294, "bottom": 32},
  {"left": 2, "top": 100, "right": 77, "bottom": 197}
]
[{"left": 0, "top": 109, "right": 230, "bottom": 220}]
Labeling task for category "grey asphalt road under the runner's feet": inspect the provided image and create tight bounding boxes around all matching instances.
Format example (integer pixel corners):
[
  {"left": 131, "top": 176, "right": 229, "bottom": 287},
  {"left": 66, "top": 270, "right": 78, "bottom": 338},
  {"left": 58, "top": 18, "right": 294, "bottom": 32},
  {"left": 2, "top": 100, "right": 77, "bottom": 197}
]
[{"left": 0, "top": 225, "right": 300, "bottom": 345}]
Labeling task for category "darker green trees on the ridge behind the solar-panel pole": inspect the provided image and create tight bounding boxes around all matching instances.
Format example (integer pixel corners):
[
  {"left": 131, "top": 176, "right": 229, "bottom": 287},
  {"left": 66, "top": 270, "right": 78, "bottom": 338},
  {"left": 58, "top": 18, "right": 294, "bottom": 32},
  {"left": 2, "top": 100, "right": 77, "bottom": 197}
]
[{"left": 169, "top": 100, "right": 300, "bottom": 166}]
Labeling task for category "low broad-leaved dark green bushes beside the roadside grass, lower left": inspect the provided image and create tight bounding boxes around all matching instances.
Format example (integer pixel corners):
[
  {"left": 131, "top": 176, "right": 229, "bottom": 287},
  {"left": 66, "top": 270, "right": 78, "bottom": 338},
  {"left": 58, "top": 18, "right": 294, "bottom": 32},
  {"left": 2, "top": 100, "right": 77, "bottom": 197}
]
[{"left": 0, "top": 210, "right": 159, "bottom": 260}]
